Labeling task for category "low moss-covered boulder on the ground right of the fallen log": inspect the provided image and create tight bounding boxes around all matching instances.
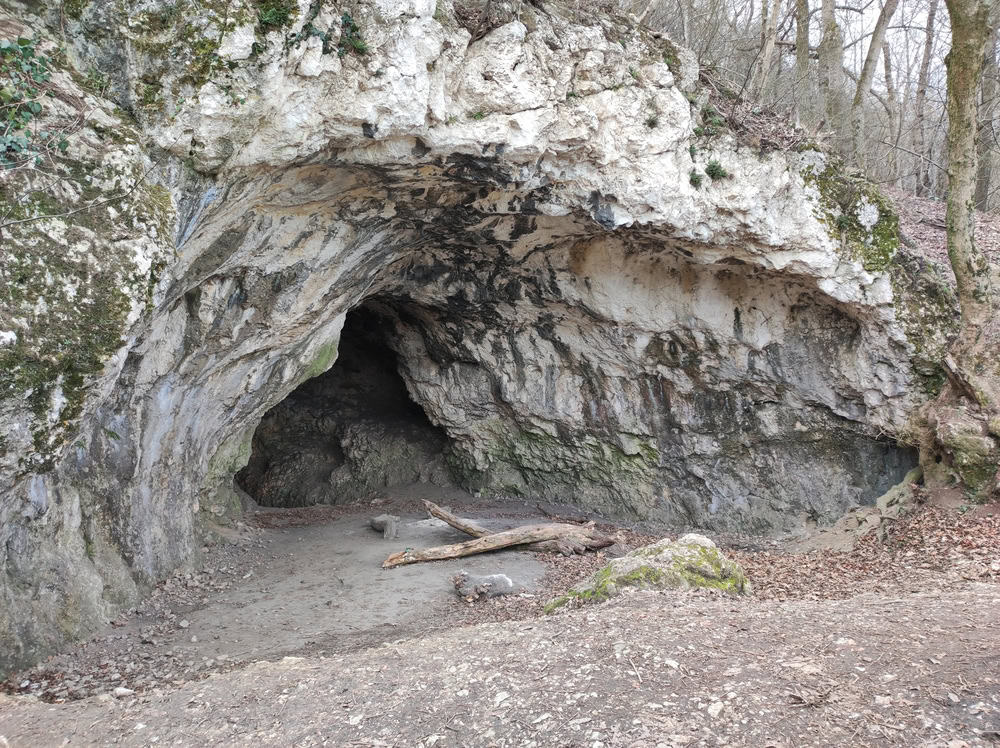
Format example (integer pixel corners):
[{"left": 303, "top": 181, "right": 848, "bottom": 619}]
[{"left": 545, "top": 533, "right": 751, "bottom": 613}]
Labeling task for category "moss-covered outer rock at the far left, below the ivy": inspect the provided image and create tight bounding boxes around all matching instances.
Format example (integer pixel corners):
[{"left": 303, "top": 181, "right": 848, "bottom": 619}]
[{"left": 0, "top": 39, "right": 175, "bottom": 472}]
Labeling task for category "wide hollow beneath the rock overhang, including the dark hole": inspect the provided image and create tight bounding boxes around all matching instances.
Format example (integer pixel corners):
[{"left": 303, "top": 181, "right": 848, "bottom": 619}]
[{"left": 229, "top": 218, "right": 916, "bottom": 533}]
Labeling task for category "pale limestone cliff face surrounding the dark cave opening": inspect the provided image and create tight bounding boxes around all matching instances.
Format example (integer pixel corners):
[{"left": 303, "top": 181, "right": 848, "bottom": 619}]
[{"left": 0, "top": 0, "right": 947, "bottom": 667}]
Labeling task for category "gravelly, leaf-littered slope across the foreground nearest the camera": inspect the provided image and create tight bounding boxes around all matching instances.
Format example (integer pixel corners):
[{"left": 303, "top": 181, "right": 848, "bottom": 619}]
[{"left": 0, "top": 582, "right": 1000, "bottom": 748}]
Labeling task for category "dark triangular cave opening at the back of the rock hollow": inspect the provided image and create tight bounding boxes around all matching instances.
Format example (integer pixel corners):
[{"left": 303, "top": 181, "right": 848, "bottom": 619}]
[{"left": 236, "top": 304, "right": 452, "bottom": 507}]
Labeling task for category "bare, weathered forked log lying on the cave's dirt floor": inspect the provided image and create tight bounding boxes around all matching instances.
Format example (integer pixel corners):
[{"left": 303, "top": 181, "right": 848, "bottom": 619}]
[{"left": 382, "top": 501, "right": 614, "bottom": 569}]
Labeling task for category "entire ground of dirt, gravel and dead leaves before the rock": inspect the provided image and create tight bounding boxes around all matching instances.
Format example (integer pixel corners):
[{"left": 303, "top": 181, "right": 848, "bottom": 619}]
[{"left": 0, "top": 485, "right": 1000, "bottom": 748}]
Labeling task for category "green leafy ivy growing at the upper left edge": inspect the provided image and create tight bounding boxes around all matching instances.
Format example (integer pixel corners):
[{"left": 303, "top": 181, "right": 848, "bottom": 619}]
[{"left": 0, "top": 37, "right": 69, "bottom": 169}]
